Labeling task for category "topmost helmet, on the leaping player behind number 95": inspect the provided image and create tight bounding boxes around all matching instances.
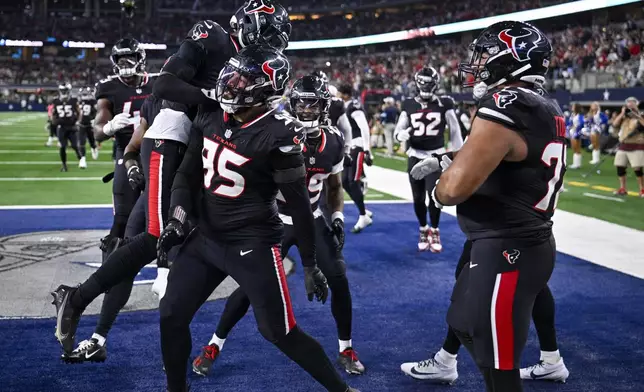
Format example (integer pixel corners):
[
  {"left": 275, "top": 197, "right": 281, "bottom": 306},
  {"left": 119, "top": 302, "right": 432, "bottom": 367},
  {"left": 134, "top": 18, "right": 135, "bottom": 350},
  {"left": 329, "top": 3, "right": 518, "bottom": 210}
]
[{"left": 230, "top": 0, "right": 291, "bottom": 50}]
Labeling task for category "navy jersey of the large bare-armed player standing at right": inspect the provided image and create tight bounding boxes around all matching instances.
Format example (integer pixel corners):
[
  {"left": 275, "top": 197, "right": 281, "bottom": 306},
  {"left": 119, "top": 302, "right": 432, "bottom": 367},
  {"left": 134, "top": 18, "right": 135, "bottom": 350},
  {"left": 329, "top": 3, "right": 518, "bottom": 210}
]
[{"left": 457, "top": 87, "right": 566, "bottom": 239}]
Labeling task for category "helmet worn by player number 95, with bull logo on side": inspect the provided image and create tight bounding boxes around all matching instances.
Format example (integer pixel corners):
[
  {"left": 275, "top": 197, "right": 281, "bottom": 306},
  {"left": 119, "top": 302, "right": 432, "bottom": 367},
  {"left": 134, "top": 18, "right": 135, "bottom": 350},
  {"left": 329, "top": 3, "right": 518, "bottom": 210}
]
[{"left": 214, "top": 45, "right": 291, "bottom": 113}]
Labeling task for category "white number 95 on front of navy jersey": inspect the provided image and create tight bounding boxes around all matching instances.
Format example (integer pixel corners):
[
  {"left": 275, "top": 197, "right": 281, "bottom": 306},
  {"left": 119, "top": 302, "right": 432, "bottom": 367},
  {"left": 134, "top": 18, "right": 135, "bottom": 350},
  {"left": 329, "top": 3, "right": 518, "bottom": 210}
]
[{"left": 202, "top": 138, "right": 250, "bottom": 199}]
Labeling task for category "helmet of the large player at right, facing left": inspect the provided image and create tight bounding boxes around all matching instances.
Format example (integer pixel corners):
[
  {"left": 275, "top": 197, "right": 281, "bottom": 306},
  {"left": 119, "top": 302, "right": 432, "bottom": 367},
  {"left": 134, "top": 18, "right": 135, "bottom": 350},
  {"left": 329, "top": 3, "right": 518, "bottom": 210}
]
[{"left": 458, "top": 21, "right": 552, "bottom": 89}]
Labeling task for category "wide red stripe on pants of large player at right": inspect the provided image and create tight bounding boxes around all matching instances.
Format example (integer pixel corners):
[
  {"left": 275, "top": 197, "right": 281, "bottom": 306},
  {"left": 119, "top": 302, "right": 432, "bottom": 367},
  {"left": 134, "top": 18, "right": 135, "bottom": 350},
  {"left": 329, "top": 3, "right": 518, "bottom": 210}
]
[{"left": 494, "top": 270, "right": 519, "bottom": 370}]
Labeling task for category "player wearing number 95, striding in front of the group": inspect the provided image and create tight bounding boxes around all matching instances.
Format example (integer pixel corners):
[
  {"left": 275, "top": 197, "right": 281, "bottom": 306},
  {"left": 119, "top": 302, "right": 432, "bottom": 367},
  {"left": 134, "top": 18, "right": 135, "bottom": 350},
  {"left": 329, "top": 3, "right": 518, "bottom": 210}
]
[{"left": 158, "top": 46, "right": 360, "bottom": 392}]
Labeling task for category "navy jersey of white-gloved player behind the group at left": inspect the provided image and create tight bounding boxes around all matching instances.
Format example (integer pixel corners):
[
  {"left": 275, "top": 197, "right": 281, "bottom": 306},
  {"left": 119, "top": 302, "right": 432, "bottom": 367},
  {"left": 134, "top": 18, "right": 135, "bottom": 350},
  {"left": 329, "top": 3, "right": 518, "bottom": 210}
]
[{"left": 96, "top": 74, "right": 157, "bottom": 148}]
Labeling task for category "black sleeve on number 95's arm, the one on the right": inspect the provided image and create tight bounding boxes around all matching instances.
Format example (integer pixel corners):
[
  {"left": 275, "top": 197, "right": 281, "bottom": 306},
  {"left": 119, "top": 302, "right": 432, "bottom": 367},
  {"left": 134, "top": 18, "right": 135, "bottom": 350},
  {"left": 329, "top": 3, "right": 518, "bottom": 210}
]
[{"left": 270, "top": 148, "right": 316, "bottom": 267}]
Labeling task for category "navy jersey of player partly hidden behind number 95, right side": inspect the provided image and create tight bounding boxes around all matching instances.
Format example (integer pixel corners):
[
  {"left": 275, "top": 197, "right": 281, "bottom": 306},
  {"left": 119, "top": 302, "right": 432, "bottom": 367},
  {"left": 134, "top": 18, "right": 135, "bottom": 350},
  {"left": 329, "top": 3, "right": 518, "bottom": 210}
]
[{"left": 277, "top": 127, "right": 344, "bottom": 217}]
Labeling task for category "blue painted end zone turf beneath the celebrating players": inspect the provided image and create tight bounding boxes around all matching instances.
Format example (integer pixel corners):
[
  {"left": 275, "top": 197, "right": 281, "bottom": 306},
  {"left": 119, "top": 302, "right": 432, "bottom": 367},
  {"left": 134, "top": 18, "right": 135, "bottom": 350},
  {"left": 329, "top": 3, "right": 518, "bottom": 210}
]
[{"left": 0, "top": 204, "right": 644, "bottom": 392}]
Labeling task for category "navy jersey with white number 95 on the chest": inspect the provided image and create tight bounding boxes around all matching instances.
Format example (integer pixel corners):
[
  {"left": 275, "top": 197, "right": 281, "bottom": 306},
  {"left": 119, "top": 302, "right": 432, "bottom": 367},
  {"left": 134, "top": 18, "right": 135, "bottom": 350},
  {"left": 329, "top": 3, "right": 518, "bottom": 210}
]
[{"left": 186, "top": 103, "right": 304, "bottom": 243}]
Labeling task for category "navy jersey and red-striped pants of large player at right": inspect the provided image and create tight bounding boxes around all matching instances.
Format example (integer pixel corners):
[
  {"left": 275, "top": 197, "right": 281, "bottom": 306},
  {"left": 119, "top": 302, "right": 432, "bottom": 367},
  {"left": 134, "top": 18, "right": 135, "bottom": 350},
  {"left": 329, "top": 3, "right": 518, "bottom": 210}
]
[{"left": 447, "top": 87, "right": 566, "bottom": 370}]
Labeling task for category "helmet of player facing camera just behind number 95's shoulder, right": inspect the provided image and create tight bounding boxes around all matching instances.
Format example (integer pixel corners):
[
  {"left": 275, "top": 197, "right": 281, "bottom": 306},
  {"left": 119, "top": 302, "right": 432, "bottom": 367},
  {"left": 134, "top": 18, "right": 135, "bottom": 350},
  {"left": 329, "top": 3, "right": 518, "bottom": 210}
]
[{"left": 290, "top": 75, "right": 331, "bottom": 131}]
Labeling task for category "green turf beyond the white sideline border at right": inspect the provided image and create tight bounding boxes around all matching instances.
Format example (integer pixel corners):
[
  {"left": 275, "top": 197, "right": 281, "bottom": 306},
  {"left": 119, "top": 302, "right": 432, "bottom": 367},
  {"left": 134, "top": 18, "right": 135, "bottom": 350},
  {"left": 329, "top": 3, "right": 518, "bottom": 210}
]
[{"left": 374, "top": 149, "right": 644, "bottom": 230}]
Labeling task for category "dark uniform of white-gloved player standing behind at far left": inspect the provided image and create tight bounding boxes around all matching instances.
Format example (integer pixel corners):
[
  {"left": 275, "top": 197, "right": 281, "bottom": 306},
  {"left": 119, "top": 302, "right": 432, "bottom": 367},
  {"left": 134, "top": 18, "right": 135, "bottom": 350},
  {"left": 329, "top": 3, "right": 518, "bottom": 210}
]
[{"left": 96, "top": 74, "right": 156, "bottom": 237}]
